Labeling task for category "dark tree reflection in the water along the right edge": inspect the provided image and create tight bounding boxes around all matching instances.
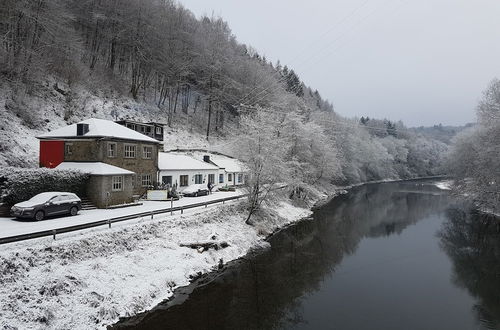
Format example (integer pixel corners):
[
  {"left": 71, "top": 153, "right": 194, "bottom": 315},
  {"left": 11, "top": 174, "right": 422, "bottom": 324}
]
[{"left": 439, "top": 209, "right": 500, "bottom": 329}]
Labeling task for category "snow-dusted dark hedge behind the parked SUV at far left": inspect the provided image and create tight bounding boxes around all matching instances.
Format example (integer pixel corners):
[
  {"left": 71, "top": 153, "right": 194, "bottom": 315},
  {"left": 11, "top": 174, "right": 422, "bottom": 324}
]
[{"left": 0, "top": 167, "right": 89, "bottom": 205}]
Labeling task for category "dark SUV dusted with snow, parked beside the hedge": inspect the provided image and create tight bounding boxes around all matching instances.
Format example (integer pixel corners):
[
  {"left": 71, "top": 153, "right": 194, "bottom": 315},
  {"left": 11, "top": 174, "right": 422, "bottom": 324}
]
[{"left": 10, "top": 192, "right": 82, "bottom": 221}]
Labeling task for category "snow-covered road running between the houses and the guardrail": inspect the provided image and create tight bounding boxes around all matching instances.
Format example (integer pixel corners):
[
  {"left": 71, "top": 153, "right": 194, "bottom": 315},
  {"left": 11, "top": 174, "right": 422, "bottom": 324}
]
[{"left": 0, "top": 191, "right": 243, "bottom": 238}]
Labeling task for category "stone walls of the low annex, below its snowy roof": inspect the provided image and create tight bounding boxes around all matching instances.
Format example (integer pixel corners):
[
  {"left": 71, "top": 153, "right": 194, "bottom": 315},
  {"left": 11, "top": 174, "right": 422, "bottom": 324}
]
[{"left": 87, "top": 175, "right": 134, "bottom": 208}]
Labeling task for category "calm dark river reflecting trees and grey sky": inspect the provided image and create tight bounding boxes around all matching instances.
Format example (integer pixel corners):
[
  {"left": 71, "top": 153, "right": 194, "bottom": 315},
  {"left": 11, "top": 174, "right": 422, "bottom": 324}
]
[{"left": 113, "top": 181, "right": 500, "bottom": 330}]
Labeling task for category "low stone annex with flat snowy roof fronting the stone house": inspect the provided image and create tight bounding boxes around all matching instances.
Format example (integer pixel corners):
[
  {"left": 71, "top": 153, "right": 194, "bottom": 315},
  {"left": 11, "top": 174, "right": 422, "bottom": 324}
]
[{"left": 56, "top": 162, "right": 135, "bottom": 208}]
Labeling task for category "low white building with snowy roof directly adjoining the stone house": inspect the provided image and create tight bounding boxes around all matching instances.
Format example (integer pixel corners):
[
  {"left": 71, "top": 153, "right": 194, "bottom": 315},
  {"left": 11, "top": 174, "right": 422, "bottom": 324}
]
[{"left": 158, "top": 152, "right": 219, "bottom": 192}]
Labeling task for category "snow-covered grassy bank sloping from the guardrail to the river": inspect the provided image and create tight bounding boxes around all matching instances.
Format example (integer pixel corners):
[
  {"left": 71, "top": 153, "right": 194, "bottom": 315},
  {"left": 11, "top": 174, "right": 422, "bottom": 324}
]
[{"left": 0, "top": 197, "right": 310, "bottom": 329}]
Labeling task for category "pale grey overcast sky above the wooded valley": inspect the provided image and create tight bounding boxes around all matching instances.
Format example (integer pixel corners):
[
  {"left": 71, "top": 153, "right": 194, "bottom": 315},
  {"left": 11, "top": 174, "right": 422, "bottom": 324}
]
[{"left": 180, "top": 0, "right": 500, "bottom": 126}]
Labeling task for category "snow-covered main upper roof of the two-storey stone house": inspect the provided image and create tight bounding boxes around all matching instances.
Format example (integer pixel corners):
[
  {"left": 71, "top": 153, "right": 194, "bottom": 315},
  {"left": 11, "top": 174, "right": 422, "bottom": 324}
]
[{"left": 37, "top": 118, "right": 160, "bottom": 143}]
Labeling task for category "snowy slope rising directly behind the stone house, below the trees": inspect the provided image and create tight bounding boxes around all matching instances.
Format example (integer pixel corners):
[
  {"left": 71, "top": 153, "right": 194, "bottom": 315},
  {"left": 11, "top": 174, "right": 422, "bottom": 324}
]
[{"left": 0, "top": 78, "right": 218, "bottom": 167}]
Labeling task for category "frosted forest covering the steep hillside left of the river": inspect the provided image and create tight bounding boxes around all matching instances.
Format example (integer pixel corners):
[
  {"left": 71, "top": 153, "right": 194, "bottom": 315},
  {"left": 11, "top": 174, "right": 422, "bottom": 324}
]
[{"left": 0, "top": 0, "right": 449, "bottom": 199}]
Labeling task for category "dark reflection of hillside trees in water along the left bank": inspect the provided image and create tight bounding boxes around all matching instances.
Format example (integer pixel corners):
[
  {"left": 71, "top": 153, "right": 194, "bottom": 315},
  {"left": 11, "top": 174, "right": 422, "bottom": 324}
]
[{"left": 113, "top": 184, "right": 446, "bottom": 329}]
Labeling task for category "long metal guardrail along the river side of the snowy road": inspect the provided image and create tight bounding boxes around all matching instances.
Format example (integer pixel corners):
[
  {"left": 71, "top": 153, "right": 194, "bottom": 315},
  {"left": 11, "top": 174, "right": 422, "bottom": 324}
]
[{"left": 0, "top": 195, "right": 246, "bottom": 245}]
